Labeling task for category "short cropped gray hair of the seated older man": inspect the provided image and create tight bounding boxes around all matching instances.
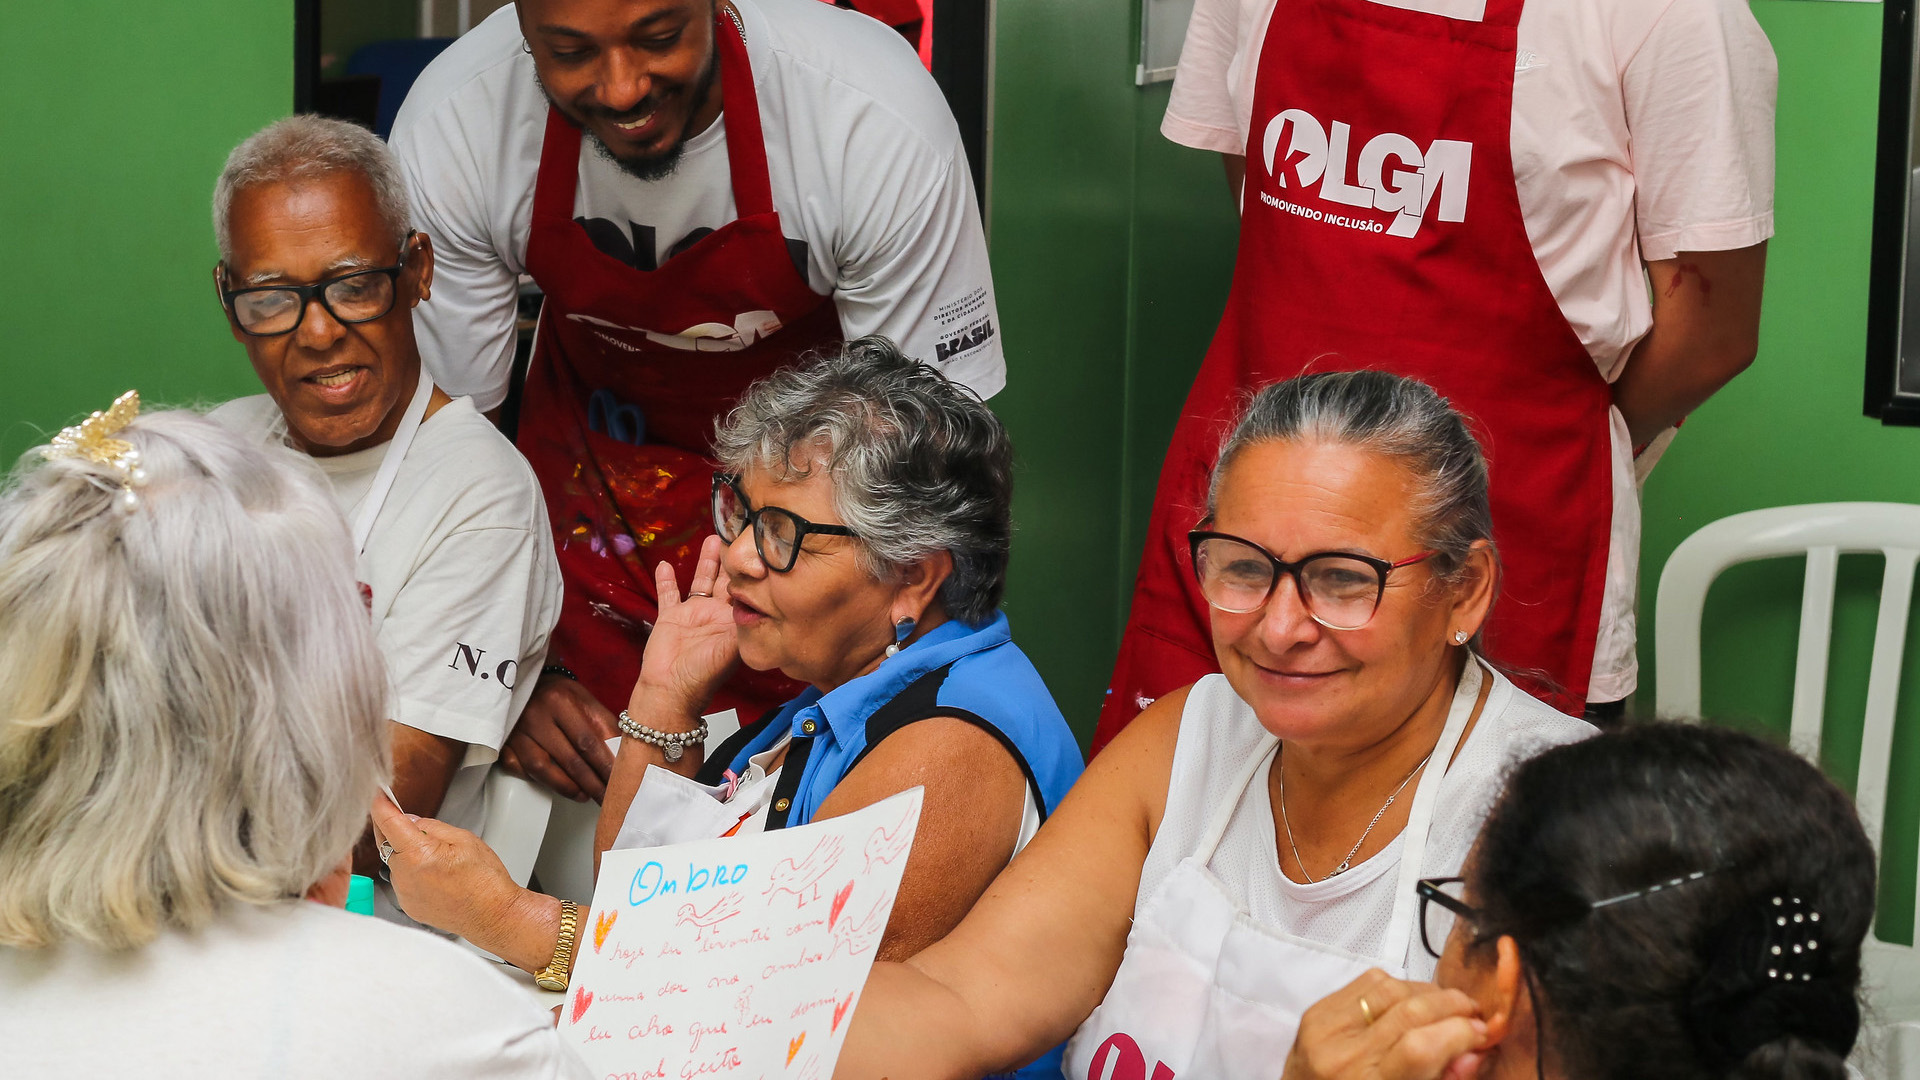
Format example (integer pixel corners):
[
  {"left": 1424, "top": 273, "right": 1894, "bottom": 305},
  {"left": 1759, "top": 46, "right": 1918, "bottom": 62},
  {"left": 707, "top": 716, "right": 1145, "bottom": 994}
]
[{"left": 213, "top": 113, "right": 413, "bottom": 259}]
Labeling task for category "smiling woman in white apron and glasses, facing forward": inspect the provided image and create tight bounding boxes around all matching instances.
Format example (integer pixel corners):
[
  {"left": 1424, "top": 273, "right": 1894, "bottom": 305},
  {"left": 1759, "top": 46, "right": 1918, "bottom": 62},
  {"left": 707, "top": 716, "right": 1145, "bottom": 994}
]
[{"left": 835, "top": 371, "right": 1592, "bottom": 1080}]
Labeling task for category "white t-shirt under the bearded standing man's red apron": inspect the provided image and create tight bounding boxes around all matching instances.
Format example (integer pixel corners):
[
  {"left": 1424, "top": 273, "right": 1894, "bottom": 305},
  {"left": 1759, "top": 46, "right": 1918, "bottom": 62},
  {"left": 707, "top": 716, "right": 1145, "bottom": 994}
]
[{"left": 394, "top": 0, "right": 1006, "bottom": 409}]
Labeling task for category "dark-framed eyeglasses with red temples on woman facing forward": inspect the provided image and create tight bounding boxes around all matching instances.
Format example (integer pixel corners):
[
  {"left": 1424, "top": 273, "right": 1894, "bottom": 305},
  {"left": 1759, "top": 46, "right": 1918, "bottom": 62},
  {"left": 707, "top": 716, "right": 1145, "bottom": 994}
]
[{"left": 1187, "top": 528, "right": 1438, "bottom": 630}]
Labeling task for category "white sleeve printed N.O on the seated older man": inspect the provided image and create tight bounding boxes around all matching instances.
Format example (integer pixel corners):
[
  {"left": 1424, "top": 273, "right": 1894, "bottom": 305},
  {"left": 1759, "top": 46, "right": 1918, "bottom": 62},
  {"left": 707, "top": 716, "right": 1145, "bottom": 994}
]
[{"left": 380, "top": 523, "right": 561, "bottom": 749}]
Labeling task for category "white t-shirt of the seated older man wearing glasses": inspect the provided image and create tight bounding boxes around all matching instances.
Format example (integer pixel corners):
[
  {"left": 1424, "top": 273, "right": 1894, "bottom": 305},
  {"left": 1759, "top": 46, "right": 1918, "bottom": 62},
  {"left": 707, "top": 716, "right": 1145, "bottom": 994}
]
[{"left": 209, "top": 394, "right": 561, "bottom": 832}]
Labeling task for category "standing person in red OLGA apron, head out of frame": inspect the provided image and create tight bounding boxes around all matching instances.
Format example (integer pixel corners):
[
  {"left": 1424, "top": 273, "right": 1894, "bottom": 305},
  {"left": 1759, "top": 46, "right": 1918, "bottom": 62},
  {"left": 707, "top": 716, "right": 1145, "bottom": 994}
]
[{"left": 1094, "top": 0, "right": 1776, "bottom": 748}]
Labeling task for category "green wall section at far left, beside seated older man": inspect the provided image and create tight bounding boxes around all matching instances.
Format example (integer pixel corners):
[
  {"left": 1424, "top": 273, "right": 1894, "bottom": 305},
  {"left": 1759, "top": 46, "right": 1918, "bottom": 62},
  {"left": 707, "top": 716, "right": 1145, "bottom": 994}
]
[{"left": 0, "top": 0, "right": 294, "bottom": 455}]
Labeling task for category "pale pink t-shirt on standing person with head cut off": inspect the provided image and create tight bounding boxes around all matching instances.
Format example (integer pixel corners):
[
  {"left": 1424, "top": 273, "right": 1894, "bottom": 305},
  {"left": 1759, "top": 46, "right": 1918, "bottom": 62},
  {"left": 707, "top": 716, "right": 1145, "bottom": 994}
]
[{"left": 1160, "top": 0, "right": 1778, "bottom": 701}]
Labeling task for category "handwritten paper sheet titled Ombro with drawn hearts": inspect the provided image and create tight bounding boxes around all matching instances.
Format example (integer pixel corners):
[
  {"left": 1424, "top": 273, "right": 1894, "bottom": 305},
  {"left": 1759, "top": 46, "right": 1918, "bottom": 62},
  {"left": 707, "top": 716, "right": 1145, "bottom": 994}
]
[{"left": 561, "top": 788, "right": 920, "bottom": 1080}]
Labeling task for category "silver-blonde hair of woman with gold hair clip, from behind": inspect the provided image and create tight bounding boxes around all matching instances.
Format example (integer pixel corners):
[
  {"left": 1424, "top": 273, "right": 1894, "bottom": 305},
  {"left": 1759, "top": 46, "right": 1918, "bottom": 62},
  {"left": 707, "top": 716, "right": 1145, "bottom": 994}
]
[{"left": 0, "top": 411, "right": 390, "bottom": 949}]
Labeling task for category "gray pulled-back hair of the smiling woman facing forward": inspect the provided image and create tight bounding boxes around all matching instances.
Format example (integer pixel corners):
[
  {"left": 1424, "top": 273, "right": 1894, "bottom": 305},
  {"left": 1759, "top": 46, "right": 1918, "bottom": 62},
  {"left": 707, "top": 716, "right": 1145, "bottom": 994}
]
[{"left": 1206, "top": 371, "right": 1498, "bottom": 578}]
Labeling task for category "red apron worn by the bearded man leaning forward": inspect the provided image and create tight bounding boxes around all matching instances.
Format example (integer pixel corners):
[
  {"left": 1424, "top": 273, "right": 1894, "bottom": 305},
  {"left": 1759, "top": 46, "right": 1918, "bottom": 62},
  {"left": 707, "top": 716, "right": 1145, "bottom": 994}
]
[{"left": 518, "top": 8, "right": 841, "bottom": 721}]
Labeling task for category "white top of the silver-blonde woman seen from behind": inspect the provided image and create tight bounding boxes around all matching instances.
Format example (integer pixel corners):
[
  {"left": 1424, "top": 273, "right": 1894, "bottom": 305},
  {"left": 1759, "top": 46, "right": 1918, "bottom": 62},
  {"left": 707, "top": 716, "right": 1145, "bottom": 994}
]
[{"left": 0, "top": 899, "right": 588, "bottom": 1080}]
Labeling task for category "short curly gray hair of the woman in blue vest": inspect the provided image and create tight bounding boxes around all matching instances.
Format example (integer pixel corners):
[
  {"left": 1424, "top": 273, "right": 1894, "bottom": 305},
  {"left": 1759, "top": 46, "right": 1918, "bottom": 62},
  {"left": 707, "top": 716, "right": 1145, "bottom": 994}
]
[{"left": 714, "top": 336, "right": 1014, "bottom": 626}]
